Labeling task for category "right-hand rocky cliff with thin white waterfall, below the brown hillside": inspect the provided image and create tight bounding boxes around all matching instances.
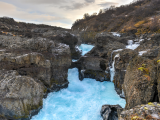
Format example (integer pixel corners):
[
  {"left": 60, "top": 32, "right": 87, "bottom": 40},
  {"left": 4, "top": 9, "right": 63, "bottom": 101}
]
[{"left": 72, "top": 32, "right": 160, "bottom": 119}]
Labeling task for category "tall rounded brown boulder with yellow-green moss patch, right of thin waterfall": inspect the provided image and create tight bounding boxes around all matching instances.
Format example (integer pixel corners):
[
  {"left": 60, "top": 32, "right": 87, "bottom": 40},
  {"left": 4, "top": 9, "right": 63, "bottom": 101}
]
[{"left": 124, "top": 57, "right": 156, "bottom": 109}]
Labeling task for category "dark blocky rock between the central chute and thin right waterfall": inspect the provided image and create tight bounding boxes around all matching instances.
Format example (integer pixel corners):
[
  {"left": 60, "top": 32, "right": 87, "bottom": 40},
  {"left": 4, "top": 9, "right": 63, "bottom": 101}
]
[{"left": 75, "top": 56, "right": 110, "bottom": 81}]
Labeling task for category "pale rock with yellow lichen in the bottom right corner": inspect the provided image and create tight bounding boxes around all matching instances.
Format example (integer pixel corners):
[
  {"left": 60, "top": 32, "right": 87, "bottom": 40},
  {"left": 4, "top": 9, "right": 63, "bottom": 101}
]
[{"left": 119, "top": 102, "right": 160, "bottom": 120}]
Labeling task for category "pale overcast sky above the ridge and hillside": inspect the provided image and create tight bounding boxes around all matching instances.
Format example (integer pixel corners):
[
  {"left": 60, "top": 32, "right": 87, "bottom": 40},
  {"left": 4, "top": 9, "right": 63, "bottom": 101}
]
[{"left": 0, "top": 0, "right": 133, "bottom": 28}]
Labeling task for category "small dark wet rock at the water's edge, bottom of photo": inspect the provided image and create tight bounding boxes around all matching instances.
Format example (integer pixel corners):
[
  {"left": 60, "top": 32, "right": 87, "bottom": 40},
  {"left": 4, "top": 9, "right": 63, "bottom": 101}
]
[{"left": 100, "top": 105, "right": 122, "bottom": 120}]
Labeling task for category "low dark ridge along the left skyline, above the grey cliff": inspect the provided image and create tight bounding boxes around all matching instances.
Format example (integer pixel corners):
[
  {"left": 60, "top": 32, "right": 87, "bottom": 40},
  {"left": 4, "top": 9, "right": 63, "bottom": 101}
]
[{"left": 0, "top": 17, "right": 70, "bottom": 38}]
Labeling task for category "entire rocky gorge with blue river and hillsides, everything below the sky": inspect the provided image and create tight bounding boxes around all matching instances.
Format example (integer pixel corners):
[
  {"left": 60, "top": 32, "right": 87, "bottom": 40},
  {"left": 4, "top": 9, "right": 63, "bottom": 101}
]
[{"left": 0, "top": 0, "right": 160, "bottom": 120}]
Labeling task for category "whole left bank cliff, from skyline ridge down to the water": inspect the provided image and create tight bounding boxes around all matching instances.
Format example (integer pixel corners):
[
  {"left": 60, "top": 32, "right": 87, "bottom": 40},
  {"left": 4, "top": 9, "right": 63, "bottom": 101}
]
[{"left": 0, "top": 18, "right": 77, "bottom": 120}]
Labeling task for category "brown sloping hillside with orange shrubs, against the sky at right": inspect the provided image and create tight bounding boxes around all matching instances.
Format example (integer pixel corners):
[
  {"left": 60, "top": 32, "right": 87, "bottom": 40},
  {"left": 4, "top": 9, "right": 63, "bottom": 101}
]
[{"left": 72, "top": 0, "right": 160, "bottom": 35}]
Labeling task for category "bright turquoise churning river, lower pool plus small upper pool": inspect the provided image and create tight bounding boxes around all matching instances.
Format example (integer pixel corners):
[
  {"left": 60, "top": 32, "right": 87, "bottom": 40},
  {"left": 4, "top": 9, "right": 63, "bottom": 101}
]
[{"left": 32, "top": 44, "right": 126, "bottom": 120}]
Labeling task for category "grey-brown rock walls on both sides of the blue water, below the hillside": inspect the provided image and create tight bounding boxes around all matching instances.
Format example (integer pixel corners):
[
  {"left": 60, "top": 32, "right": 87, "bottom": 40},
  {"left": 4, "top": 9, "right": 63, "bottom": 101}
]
[{"left": 0, "top": 13, "right": 160, "bottom": 120}]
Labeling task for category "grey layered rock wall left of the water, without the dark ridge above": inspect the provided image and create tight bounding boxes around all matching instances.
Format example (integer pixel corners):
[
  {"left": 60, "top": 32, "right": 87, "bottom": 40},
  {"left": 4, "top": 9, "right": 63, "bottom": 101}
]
[{"left": 0, "top": 35, "right": 71, "bottom": 119}]
